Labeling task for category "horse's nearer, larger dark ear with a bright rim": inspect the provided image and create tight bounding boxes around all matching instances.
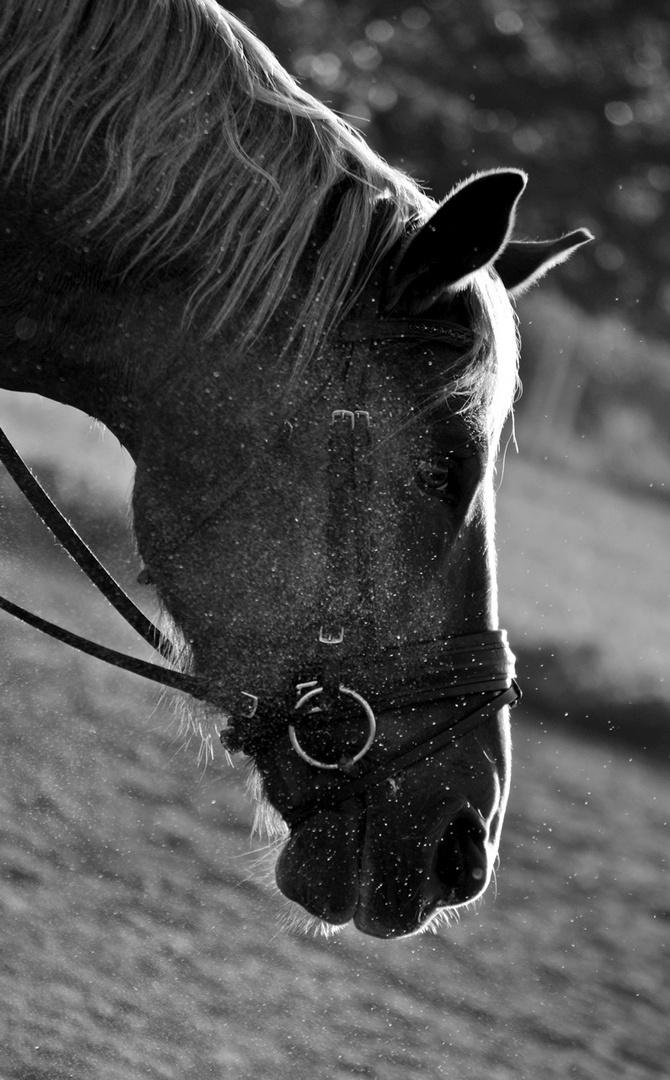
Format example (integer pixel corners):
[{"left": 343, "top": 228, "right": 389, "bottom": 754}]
[{"left": 386, "top": 168, "right": 526, "bottom": 313}]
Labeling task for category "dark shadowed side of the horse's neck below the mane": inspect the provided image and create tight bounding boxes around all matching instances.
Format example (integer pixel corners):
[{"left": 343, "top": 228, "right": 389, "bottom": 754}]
[{"left": 0, "top": 197, "right": 193, "bottom": 457}]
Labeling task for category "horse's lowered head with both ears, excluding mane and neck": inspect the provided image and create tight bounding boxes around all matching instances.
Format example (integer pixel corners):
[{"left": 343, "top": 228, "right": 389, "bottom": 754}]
[{"left": 125, "top": 171, "right": 586, "bottom": 936}]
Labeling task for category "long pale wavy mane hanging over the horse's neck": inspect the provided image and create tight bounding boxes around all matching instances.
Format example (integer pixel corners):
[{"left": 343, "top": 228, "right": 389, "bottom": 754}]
[{"left": 0, "top": 0, "right": 434, "bottom": 356}]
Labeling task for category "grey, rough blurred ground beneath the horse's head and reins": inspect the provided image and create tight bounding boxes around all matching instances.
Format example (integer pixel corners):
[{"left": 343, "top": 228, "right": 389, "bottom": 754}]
[{"left": 0, "top": 627, "right": 670, "bottom": 1080}]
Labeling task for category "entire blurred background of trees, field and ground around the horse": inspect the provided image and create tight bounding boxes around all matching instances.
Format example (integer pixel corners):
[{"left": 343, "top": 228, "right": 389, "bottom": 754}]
[{"left": 0, "top": 0, "right": 670, "bottom": 1080}]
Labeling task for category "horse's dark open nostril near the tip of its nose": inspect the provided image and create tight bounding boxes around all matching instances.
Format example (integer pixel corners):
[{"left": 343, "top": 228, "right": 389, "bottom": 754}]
[{"left": 433, "top": 807, "right": 488, "bottom": 906}]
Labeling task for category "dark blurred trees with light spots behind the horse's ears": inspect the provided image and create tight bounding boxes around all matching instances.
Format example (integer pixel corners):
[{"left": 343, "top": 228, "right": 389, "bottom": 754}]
[{"left": 228, "top": 0, "right": 670, "bottom": 337}]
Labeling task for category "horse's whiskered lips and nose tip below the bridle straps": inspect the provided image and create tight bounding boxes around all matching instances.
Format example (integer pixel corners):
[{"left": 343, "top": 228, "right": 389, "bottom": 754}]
[{"left": 276, "top": 799, "right": 492, "bottom": 937}]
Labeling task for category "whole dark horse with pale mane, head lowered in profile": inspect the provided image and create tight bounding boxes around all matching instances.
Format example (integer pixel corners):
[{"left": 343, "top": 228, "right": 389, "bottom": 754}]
[{"left": 0, "top": 0, "right": 590, "bottom": 937}]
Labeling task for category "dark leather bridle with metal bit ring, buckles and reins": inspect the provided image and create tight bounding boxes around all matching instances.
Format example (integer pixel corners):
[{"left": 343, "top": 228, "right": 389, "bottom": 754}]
[{"left": 0, "top": 320, "right": 521, "bottom": 825}]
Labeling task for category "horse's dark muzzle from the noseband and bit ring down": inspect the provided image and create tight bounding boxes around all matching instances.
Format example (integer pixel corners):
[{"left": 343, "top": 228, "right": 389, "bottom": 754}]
[{"left": 256, "top": 632, "right": 519, "bottom": 937}]
